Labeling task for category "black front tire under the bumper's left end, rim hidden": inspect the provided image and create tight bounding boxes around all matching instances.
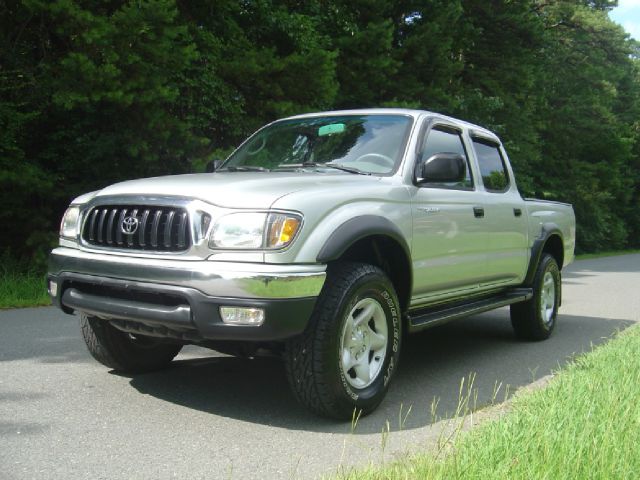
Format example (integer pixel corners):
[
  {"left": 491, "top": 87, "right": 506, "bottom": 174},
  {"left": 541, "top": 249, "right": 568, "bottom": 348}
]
[{"left": 80, "top": 314, "right": 182, "bottom": 373}]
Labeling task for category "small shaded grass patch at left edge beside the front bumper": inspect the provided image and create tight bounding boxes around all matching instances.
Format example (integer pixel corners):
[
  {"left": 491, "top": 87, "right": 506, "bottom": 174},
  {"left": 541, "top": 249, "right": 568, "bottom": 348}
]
[{"left": 0, "top": 263, "right": 51, "bottom": 308}]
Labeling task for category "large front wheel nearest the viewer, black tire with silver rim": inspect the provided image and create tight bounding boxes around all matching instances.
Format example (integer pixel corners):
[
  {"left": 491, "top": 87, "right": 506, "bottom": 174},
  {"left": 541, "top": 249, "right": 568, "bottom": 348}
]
[{"left": 285, "top": 263, "right": 402, "bottom": 420}]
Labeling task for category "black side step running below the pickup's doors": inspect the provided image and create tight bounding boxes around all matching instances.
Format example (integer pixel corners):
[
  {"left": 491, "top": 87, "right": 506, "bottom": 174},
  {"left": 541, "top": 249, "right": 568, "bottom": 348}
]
[{"left": 407, "top": 288, "right": 533, "bottom": 332}]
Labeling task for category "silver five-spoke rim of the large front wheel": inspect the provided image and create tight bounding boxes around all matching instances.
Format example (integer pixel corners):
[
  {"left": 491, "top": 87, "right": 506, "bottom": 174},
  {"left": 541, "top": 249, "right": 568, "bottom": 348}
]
[{"left": 340, "top": 298, "right": 389, "bottom": 388}]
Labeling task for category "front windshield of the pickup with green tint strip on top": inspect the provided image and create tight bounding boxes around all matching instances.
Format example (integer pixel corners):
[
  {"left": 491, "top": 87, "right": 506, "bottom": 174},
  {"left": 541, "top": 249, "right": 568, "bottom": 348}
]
[{"left": 222, "top": 115, "right": 411, "bottom": 175}]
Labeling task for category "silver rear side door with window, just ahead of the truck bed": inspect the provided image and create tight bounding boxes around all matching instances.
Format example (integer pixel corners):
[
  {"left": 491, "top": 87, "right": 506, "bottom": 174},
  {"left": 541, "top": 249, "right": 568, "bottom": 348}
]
[{"left": 472, "top": 136, "right": 528, "bottom": 287}]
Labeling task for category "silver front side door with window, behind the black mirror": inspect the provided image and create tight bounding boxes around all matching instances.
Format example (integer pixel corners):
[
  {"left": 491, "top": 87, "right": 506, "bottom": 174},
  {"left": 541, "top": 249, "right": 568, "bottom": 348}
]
[{"left": 411, "top": 123, "right": 487, "bottom": 307}]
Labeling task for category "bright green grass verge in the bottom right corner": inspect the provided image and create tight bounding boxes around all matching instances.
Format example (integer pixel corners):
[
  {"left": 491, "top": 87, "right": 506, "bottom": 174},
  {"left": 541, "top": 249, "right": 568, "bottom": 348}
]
[{"left": 339, "top": 327, "right": 640, "bottom": 480}]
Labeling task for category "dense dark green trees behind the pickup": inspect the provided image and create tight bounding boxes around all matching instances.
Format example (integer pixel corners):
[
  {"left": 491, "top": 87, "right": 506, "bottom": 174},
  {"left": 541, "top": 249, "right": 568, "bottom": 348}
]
[{"left": 0, "top": 0, "right": 640, "bottom": 264}]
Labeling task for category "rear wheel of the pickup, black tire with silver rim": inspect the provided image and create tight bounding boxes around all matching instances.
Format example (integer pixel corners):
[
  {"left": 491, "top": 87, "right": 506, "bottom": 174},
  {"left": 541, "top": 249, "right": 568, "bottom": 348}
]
[{"left": 511, "top": 254, "right": 562, "bottom": 340}]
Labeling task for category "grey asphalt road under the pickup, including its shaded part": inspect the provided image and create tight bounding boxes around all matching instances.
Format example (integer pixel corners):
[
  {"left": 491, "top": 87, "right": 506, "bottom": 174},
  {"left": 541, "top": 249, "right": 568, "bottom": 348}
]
[{"left": 0, "top": 255, "right": 640, "bottom": 479}]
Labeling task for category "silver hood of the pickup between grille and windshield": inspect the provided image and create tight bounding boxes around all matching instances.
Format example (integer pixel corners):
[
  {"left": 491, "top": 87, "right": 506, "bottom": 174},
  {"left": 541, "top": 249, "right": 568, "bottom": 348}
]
[{"left": 97, "top": 172, "right": 380, "bottom": 209}]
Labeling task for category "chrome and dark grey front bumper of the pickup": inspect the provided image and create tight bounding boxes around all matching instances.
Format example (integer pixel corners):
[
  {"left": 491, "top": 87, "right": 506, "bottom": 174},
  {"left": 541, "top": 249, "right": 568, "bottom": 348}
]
[{"left": 48, "top": 247, "right": 326, "bottom": 343}]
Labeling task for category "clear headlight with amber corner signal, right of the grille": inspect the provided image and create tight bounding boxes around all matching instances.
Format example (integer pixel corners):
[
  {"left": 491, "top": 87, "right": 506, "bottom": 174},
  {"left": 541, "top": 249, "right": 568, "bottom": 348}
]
[{"left": 209, "top": 212, "right": 302, "bottom": 250}]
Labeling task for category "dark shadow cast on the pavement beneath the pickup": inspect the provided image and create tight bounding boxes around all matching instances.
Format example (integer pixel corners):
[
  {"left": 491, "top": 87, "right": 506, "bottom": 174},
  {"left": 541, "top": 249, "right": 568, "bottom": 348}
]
[{"left": 130, "top": 309, "right": 634, "bottom": 434}]
